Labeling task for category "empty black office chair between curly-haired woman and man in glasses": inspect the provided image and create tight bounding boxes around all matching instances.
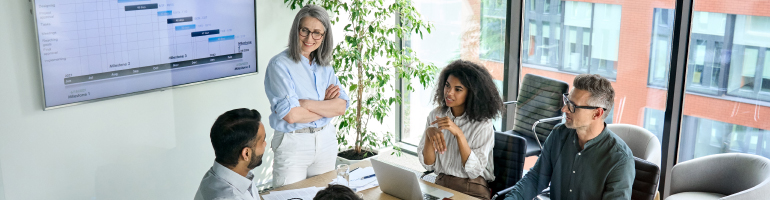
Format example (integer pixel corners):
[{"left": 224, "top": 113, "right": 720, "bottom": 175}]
[{"left": 496, "top": 74, "right": 569, "bottom": 157}]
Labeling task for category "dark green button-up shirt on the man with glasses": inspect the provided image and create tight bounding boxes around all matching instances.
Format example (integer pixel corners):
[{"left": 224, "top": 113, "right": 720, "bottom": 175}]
[{"left": 505, "top": 124, "right": 636, "bottom": 200}]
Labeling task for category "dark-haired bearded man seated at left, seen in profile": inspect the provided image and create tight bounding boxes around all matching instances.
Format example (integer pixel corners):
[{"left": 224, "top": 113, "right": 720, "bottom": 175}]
[{"left": 195, "top": 108, "right": 266, "bottom": 200}]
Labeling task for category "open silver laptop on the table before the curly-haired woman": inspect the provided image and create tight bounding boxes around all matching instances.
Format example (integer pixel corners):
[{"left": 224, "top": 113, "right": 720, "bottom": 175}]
[{"left": 371, "top": 159, "right": 454, "bottom": 200}]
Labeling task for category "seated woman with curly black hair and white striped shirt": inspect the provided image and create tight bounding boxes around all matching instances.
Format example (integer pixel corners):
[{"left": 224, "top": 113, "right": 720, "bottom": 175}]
[{"left": 417, "top": 60, "right": 503, "bottom": 199}]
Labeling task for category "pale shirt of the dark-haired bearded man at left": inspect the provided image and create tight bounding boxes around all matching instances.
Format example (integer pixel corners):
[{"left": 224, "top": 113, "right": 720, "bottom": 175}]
[{"left": 195, "top": 162, "right": 260, "bottom": 200}]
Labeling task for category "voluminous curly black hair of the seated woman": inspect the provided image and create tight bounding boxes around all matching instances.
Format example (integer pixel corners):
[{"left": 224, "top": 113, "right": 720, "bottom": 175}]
[{"left": 433, "top": 60, "right": 503, "bottom": 122}]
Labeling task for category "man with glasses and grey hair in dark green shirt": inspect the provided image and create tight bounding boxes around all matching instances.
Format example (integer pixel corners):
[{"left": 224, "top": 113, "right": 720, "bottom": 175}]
[{"left": 505, "top": 74, "right": 636, "bottom": 200}]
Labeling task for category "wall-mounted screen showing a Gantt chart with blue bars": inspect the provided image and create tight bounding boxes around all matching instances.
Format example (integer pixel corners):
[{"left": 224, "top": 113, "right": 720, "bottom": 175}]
[{"left": 34, "top": 0, "right": 257, "bottom": 107}]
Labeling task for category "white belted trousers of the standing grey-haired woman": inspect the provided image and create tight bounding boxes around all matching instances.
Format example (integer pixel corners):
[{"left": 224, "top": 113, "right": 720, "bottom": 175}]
[{"left": 272, "top": 125, "right": 337, "bottom": 187}]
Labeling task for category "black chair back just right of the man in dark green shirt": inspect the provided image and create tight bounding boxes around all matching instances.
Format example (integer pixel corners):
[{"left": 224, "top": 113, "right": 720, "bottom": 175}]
[{"left": 631, "top": 157, "right": 660, "bottom": 200}]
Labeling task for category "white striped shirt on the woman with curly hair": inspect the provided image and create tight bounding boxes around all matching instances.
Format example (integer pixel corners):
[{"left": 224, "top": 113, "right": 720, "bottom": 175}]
[{"left": 417, "top": 108, "right": 495, "bottom": 181}]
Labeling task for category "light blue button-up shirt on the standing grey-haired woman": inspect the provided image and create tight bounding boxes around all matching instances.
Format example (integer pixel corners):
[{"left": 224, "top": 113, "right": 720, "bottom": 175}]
[{"left": 265, "top": 49, "right": 350, "bottom": 133}]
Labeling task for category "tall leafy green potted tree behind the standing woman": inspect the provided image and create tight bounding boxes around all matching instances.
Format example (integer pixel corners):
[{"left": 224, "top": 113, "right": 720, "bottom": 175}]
[{"left": 284, "top": 0, "right": 436, "bottom": 162}]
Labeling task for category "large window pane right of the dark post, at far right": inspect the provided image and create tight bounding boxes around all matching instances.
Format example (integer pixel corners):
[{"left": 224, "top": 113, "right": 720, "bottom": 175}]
[{"left": 679, "top": 0, "right": 770, "bottom": 162}]
